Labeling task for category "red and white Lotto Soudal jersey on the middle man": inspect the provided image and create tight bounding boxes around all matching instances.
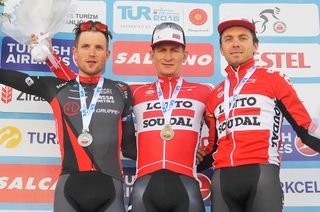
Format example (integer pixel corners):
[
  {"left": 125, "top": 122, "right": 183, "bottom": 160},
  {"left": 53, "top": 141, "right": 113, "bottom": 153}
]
[{"left": 46, "top": 55, "right": 212, "bottom": 178}]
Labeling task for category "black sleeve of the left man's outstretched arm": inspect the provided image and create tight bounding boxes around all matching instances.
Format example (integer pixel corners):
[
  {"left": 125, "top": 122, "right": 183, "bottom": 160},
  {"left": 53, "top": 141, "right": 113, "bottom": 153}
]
[{"left": 0, "top": 69, "right": 55, "bottom": 102}]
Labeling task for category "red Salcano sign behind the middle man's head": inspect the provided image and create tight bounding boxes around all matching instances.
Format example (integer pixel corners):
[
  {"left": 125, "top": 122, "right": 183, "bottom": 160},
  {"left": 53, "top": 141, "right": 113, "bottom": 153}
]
[{"left": 112, "top": 41, "right": 214, "bottom": 77}]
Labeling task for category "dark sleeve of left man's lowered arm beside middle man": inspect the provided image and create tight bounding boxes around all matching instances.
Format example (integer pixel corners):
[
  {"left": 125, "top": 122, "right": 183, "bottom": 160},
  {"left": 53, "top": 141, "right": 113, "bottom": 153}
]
[{"left": 120, "top": 83, "right": 137, "bottom": 160}]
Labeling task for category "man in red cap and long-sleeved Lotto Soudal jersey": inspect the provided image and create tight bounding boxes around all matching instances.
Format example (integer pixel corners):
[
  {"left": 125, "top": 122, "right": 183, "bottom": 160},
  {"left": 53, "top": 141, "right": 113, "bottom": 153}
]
[{"left": 199, "top": 16, "right": 320, "bottom": 212}]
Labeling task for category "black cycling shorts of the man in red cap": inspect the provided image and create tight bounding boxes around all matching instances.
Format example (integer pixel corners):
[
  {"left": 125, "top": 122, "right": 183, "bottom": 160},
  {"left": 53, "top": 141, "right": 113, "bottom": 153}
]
[{"left": 211, "top": 164, "right": 283, "bottom": 212}]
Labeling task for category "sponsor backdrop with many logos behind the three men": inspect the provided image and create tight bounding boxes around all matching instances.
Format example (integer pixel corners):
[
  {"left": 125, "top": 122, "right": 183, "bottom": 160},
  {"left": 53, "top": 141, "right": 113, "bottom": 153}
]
[{"left": 0, "top": 0, "right": 320, "bottom": 212}]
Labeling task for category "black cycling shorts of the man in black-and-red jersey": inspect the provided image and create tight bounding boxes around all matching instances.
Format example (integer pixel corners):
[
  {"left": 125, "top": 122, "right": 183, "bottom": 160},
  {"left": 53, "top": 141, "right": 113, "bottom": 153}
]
[{"left": 53, "top": 171, "right": 125, "bottom": 212}]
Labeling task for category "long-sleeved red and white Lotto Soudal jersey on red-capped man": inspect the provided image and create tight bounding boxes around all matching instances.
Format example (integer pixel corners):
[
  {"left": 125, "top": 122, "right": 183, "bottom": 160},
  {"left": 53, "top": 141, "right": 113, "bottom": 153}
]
[{"left": 206, "top": 59, "right": 320, "bottom": 168}]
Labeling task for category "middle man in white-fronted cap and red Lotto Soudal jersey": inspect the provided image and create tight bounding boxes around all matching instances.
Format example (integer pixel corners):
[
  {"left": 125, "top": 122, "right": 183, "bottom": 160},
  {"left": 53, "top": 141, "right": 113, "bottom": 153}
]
[{"left": 39, "top": 22, "right": 212, "bottom": 212}]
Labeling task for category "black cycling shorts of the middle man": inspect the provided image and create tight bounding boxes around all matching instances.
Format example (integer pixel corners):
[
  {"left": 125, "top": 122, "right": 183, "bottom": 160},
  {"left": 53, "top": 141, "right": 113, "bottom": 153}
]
[{"left": 128, "top": 169, "right": 205, "bottom": 212}]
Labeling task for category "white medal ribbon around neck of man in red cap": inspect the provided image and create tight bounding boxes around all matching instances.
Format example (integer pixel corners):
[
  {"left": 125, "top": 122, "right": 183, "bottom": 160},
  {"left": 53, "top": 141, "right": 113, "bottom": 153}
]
[{"left": 223, "top": 66, "right": 256, "bottom": 121}]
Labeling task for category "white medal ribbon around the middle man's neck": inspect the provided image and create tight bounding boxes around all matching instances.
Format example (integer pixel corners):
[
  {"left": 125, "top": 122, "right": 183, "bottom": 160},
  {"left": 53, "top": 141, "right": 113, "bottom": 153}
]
[{"left": 156, "top": 78, "right": 182, "bottom": 124}]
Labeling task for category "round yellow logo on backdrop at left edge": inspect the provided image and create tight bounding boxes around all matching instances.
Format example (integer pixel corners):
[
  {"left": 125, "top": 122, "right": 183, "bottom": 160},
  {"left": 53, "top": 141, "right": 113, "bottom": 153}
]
[{"left": 0, "top": 126, "right": 22, "bottom": 148}]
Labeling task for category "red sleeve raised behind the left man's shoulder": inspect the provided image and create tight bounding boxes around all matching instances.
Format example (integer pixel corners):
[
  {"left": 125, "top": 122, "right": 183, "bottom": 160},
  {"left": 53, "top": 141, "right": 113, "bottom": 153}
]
[{"left": 46, "top": 54, "right": 77, "bottom": 80}]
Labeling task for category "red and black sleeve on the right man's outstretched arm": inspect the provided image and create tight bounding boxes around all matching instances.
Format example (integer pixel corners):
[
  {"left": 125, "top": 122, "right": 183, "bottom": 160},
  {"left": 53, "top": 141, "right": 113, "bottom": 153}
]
[{"left": 272, "top": 72, "right": 320, "bottom": 152}]
